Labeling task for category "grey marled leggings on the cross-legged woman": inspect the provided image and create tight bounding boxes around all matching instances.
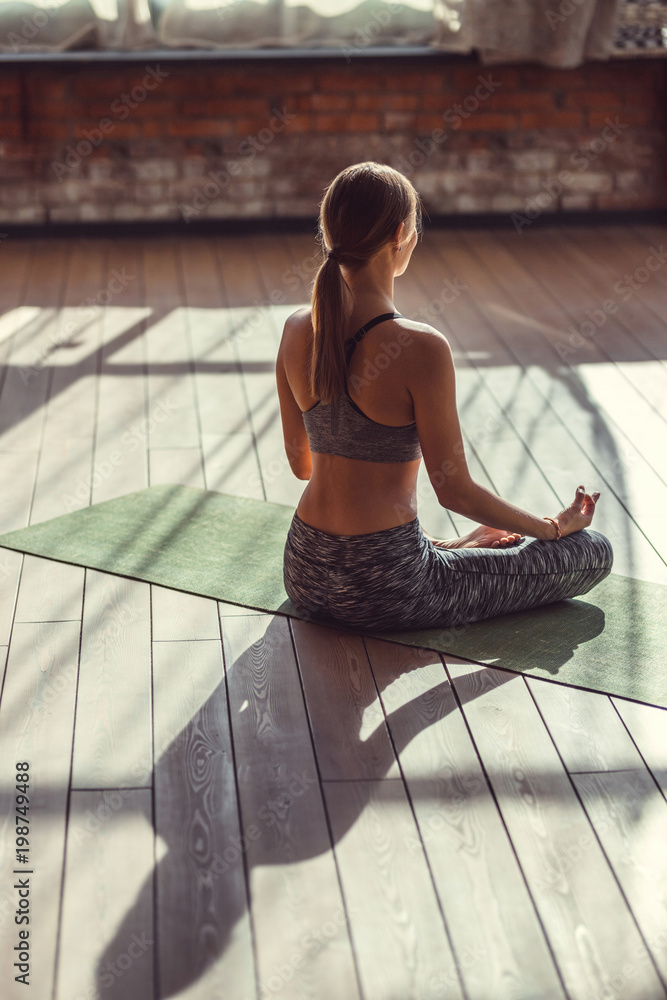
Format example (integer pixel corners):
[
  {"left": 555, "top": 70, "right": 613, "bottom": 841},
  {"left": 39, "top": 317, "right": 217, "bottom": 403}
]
[{"left": 283, "top": 512, "right": 613, "bottom": 630}]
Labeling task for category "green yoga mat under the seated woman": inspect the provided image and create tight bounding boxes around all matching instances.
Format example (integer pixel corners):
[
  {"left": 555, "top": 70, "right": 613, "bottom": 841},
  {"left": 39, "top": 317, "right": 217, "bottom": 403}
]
[{"left": 0, "top": 486, "right": 667, "bottom": 707}]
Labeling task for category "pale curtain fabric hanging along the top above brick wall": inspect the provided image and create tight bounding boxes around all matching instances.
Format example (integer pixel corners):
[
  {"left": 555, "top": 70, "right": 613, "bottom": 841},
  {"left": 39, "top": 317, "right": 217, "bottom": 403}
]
[{"left": 0, "top": 0, "right": 655, "bottom": 67}]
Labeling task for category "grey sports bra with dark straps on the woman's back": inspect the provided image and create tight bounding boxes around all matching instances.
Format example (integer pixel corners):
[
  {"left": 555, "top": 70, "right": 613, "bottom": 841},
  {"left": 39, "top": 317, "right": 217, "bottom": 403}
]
[{"left": 303, "top": 312, "right": 422, "bottom": 462}]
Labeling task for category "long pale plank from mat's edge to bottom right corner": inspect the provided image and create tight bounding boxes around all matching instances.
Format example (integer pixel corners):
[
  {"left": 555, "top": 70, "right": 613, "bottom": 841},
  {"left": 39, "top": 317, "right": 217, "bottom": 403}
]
[{"left": 446, "top": 657, "right": 662, "bottom": 1000}]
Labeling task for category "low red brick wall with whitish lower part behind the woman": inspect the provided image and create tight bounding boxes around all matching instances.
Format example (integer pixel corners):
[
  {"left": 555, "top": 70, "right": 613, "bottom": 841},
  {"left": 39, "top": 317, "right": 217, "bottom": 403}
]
[{"left": 0, "top": 56, "right": 667, "bottom": 226}]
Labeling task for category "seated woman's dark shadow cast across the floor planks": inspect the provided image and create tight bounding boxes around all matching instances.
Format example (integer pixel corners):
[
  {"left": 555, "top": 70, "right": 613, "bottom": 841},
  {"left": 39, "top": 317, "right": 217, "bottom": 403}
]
[{"left": 97, "top": 601, "right": 604, "bottom": 1000}]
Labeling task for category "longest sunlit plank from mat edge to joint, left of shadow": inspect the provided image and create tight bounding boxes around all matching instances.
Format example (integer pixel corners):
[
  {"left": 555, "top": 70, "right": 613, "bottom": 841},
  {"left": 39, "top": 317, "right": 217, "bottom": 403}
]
[{"left": 72, "top": 569, "right": 152, "bottom": 788}]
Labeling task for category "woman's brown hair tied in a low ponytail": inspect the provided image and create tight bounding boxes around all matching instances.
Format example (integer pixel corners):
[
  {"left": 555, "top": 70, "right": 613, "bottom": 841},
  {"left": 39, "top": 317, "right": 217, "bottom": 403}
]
[{"left": 308, "top": 160, "right": 422, "bottom": 403}]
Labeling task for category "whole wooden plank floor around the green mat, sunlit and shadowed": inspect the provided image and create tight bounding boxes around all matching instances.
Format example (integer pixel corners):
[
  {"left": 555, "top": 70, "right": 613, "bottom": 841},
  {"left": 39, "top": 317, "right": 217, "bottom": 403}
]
[{"left": 0, "top": 224, "right": 667, "bottom": 1000}]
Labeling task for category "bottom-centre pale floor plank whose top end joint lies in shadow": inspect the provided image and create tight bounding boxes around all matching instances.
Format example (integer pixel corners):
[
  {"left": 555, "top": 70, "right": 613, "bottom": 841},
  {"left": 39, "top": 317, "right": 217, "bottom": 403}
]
[{"left": 322, "top": 781, "right": 463, "bottom": 1000}]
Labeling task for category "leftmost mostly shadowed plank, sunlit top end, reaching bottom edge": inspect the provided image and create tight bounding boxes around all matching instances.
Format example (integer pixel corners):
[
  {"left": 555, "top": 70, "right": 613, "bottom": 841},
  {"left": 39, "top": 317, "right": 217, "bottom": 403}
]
[{"left": 153, "top": 637, "right": 255, "bottom": 1000}]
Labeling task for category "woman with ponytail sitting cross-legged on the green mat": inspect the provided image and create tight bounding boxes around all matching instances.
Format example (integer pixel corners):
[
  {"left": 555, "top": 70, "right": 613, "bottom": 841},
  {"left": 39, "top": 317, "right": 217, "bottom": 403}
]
[{"left": 276, "top": 162, "right": 613, "bottom": 630}]
